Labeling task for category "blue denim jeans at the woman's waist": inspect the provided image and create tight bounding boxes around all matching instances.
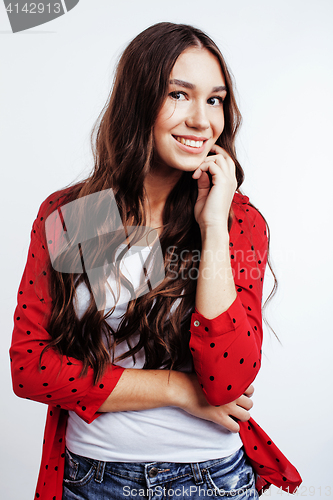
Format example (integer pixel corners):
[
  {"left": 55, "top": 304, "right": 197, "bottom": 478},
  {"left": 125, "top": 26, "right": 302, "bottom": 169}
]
[{"left": 62, "top": 448, "right": 259, "bottom": 500}]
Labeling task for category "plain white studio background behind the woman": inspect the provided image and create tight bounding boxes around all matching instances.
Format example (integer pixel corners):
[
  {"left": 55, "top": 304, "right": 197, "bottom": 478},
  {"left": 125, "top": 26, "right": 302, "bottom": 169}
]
[{"left": 0, "top": 0, "right": 333, "bottom": 500}]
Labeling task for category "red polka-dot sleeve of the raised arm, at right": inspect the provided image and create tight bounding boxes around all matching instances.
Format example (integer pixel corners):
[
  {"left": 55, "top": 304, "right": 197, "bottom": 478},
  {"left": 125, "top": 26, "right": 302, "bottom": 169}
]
[{"left": 190, "top": 204, "right": 267, "bottom": 405}]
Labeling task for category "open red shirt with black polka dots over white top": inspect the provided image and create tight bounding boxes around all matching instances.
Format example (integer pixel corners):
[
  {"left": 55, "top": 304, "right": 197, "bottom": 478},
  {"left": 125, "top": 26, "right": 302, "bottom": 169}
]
[{"left": 10, "top": 189, "right": 302, "bottom": 500}]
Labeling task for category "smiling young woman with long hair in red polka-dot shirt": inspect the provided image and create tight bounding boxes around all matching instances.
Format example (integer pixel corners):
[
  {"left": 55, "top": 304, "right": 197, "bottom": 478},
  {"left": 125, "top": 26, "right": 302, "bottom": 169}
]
[{"left": 10, "top": 23, "right": 301, "bottom": 500}]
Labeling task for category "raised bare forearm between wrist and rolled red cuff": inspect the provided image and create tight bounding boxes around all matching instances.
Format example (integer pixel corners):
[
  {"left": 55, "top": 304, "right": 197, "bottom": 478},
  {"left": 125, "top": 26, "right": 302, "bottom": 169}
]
[{"left": 195, "top": 227, "right": 237, "bottom": 319}]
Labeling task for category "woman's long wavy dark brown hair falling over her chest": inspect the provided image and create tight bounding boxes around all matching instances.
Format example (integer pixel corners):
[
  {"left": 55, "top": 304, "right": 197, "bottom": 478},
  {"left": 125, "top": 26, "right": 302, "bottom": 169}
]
[{"left": 39, "top": 22, "right": 276, "bottom": 382}]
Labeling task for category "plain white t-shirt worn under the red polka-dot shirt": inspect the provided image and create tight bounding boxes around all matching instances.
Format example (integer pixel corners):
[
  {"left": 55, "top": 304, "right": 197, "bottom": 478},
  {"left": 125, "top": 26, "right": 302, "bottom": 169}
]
[{"left": 66, "top": 242, "right": 243, "bottom": 462}]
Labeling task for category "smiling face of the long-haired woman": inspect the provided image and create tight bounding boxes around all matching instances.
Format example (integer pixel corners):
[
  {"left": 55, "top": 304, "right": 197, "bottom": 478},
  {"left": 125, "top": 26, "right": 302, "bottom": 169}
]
[{"left": 154, "top": 47, "right": 227, "bottom": 171}]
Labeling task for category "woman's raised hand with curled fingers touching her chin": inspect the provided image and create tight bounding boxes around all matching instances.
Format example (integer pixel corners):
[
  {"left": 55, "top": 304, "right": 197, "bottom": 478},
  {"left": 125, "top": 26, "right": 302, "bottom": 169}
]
[{"left": 192, "top": 144, "right": 237, "bottom": 230}]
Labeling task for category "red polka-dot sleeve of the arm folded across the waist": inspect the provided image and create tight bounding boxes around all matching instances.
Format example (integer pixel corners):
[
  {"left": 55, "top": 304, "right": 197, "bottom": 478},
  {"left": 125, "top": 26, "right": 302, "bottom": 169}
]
[{"left": 10, "top": 200, "right": 123, "bottom": 423}]
